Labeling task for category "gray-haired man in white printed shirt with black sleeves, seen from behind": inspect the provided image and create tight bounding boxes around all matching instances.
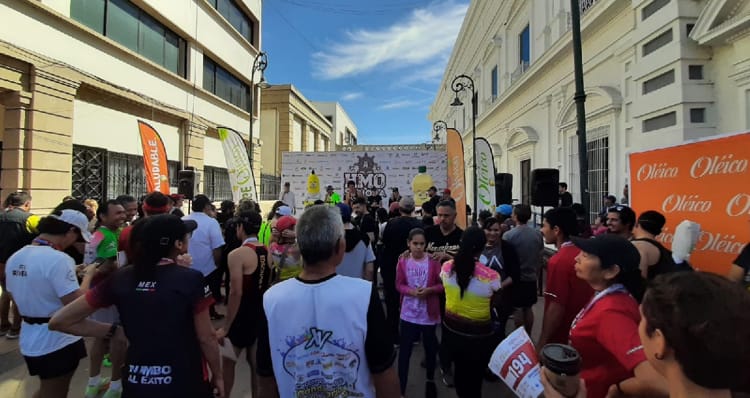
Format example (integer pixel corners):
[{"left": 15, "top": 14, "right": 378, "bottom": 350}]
[{"left": 257, "top": 205, "right": 400, "bottom": 398}]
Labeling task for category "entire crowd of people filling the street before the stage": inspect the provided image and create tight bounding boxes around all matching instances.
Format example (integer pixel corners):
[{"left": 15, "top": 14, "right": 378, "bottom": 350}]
[{"left": 0, "top": 184, "right": 750, "bottom": 398}]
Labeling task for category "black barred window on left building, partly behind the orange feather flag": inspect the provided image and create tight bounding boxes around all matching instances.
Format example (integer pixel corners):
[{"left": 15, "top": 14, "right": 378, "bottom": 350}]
[{"left": 71, "top": 145, "right": 180, "bottom": 201}]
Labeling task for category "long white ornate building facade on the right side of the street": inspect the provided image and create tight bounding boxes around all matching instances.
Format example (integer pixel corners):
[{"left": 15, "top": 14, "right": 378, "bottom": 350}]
[{"left": 428, "top": 0, "right": 750, "bottom": 218}]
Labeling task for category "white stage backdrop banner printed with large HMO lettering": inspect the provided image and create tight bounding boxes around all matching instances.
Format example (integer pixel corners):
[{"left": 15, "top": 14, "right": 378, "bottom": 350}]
[{"left": 281, "top": 150, "right": 447, "bottom": 210}]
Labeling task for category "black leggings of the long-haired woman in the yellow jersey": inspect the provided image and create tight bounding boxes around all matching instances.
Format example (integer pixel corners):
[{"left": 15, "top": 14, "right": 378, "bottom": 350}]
[{"left": 442, "top": 327, "right": 495, "bottom": 398}]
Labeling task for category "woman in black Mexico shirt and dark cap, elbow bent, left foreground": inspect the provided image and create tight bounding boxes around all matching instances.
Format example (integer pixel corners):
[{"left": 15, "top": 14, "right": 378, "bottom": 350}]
[{"left": 49, "top": 214, "right": 224, "bottom": 398}]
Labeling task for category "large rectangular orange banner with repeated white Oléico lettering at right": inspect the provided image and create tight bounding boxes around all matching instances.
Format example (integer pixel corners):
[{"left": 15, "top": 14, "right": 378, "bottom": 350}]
[{"left": 630, "top": 133, "right": 750, "bottom": 275}]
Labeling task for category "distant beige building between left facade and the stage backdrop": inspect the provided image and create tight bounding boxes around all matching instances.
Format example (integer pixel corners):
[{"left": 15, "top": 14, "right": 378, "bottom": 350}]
[{"left": 260, "top": 84, "right": 335, "bottom": 200}]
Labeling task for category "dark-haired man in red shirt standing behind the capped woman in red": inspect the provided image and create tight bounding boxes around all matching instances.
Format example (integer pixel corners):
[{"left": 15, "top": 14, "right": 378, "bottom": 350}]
[{"left": 537, "top": 207, "right": 594, "bottom": 350}]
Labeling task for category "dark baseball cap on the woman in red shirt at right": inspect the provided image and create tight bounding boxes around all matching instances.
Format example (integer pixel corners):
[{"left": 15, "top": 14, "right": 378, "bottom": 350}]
[{"left": 571, "top": 234, "right": 641, "bottom": 272}]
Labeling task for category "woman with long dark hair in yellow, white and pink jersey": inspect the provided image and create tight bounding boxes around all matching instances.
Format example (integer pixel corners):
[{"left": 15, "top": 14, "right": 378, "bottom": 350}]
[{"left": 440, "top": 227, "right": 501, "bottom": 398}]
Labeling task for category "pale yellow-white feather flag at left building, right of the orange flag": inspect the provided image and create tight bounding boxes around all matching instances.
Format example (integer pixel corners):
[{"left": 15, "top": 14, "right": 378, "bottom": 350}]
[{"left": 217, "top": 127, "right": 258, "bottom": 203}]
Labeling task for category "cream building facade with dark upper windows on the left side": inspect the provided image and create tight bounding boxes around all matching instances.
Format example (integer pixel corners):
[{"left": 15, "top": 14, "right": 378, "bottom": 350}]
[{"left": 0, "top": 0, "right": 261, "bottom": 211}]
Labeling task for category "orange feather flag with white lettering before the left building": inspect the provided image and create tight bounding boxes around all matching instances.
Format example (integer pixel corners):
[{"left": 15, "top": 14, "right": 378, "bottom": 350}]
[{"left": 138, "top": 120, "right": 169, "bottom": 195}]
